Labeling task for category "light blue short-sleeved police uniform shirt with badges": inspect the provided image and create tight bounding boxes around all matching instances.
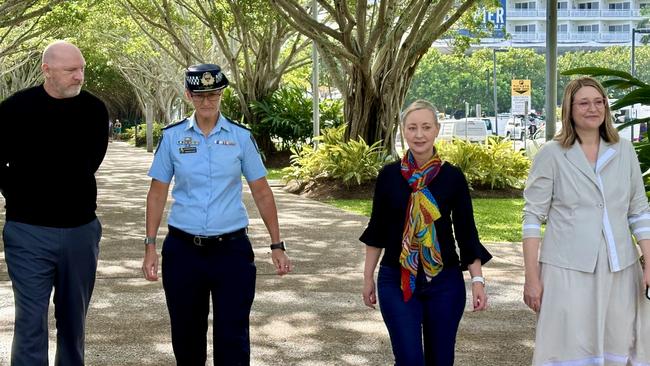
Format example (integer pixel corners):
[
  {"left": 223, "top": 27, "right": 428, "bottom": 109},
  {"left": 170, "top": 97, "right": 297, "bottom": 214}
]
[{"left": 149, "top": 114, "right": 266, "bottom": 236}]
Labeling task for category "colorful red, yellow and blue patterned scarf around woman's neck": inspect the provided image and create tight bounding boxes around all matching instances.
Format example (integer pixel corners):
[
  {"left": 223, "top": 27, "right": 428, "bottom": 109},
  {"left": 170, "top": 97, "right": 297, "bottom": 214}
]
[{"left": 399, "top": 147, "right": 442, "bottom": 302}]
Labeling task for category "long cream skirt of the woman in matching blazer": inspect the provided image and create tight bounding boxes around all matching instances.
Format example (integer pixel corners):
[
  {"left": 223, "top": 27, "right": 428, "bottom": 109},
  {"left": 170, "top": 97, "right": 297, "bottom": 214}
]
[{"left": 533, "top": 243, "right": 650, "bottom": 366}]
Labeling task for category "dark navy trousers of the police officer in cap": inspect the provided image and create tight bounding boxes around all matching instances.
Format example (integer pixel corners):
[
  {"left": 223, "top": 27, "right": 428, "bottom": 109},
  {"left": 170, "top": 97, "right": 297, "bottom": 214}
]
[{"left": 162, "top": 235, "right": 256, "bottom": 366}]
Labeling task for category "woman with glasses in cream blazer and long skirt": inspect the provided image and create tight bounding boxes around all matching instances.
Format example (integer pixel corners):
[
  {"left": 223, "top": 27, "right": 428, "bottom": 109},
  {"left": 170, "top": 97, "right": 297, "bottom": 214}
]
[{"left": 523, "top": 77, "right": 650, "bottom": 366}]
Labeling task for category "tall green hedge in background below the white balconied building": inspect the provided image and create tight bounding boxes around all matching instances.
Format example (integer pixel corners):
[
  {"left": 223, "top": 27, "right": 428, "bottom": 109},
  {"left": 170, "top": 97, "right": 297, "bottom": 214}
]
[{"left": 405, "top": 46, "right": 650, "bottom": 115}]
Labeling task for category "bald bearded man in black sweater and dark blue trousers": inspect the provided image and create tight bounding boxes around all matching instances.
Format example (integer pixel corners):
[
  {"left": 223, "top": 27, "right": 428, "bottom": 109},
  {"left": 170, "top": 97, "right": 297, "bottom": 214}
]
[{"left": 0, "top": 41, "right": 108, "bottom": 366}]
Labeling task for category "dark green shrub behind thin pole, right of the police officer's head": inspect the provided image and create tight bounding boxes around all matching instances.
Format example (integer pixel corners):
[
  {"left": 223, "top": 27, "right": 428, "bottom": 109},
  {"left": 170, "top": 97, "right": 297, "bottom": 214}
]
[{"left": 251, "top": 86, "right": 343, "bottom": 150}]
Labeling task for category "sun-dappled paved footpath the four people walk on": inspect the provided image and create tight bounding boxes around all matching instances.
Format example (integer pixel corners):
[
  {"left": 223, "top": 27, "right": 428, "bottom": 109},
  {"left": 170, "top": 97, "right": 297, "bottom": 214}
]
[{"left": 0, "top": 142, "right": 535, "bottom": 366}]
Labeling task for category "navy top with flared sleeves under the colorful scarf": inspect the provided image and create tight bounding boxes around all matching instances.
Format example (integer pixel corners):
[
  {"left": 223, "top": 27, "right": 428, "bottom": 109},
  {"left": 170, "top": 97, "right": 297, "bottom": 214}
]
[{"left": 359, "top": 161, "right": 492, "bottom": 270}]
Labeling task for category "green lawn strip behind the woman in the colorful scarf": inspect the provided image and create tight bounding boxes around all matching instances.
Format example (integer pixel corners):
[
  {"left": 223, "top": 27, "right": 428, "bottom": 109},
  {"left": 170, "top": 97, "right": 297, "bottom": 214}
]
[{"left": 325, "top": 198, "right": 524, "bottom": 242}]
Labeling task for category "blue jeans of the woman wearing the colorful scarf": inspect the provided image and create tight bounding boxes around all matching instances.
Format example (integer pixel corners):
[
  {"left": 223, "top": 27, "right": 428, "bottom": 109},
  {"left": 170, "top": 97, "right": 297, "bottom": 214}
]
[{"left": 377, "top": 266, "right": 465, "bottom": 366}]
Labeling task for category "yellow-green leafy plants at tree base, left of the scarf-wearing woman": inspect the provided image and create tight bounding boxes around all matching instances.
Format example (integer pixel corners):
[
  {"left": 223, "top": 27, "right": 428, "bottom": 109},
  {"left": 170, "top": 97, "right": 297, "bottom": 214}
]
[{"left": 283, "top": 126, "right": 390, "bottom": 186}]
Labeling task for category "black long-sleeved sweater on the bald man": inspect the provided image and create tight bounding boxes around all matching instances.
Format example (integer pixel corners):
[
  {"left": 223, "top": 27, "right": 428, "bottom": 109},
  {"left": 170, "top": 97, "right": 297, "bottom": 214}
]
[{"left": 0, "top": 85, "right": 108, "bottom": 227}]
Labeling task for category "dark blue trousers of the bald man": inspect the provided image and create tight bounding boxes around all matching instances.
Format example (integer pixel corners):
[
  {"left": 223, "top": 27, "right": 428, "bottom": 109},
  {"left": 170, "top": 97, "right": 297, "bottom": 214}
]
[{"left": 3, "top": 219, "right": 102, "bottom": 366}]
